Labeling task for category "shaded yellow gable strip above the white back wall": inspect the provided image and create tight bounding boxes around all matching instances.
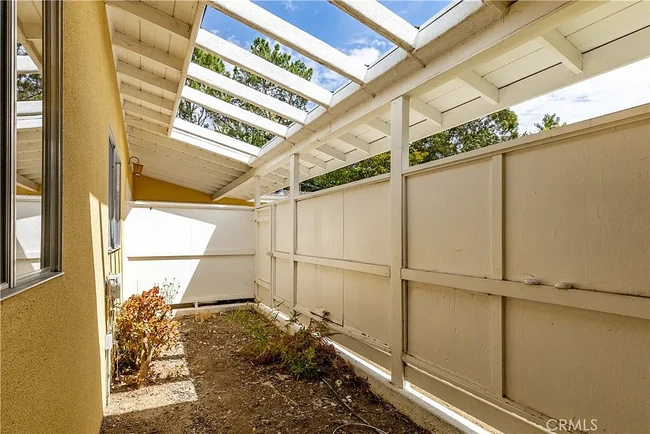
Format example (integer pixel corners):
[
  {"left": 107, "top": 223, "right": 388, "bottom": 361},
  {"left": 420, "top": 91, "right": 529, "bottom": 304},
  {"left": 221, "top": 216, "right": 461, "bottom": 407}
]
[{"left": 133, "top": 174, "right": 253, "bottom": 206}]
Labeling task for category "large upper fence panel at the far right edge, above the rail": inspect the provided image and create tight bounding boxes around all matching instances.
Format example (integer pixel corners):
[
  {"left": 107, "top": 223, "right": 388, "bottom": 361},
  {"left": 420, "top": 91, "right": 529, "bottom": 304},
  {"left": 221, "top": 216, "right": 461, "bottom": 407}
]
[{"left": 504, "top": 122, "right": 650, "bottom": 296}]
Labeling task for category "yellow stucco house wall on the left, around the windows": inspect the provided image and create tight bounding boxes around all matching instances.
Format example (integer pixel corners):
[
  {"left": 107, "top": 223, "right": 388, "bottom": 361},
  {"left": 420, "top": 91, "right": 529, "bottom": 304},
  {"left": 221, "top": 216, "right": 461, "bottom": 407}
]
[{"left": 0, "top": 1, "right": 130, "bottom": 434}]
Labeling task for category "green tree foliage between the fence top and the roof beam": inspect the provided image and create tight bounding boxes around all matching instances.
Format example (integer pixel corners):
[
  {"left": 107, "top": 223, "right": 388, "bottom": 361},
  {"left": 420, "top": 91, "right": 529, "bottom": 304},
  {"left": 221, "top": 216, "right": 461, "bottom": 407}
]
[{"left": 301, "top": 109, "right": 519, "bottom": 191}]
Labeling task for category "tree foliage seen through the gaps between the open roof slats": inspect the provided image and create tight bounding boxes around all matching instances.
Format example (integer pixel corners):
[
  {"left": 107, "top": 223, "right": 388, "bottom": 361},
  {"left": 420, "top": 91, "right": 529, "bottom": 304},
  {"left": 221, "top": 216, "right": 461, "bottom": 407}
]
[{"left": 178, "top": 38, "right": 313, "bottom": 147}]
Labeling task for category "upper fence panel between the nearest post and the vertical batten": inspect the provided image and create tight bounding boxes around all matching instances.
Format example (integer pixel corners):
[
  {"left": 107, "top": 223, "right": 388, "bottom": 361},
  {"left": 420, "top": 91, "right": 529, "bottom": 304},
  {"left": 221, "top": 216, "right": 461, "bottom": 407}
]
[{"left": 406, "top": 160, "right": 491, "bottom": 277}]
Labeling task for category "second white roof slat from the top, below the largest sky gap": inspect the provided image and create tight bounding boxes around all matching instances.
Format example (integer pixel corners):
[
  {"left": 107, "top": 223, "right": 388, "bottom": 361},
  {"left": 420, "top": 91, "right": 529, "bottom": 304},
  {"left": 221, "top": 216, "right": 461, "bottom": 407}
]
[{"left": 211, "top": 0, "right": 368, "bottom": 84}]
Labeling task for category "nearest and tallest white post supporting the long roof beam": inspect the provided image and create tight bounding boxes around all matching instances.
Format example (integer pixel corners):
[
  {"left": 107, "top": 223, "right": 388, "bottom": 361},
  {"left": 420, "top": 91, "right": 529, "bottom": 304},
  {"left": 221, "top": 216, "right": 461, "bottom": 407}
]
[{"left": 390, "top": 96, "right": 410, "bottom": 388}]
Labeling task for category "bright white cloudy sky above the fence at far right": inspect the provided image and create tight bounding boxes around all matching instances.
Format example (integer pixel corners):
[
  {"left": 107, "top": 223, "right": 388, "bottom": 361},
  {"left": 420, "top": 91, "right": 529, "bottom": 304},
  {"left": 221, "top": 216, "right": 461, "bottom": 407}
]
[{"left": 512, "top": 59, "right": 650, "bottom": 132}]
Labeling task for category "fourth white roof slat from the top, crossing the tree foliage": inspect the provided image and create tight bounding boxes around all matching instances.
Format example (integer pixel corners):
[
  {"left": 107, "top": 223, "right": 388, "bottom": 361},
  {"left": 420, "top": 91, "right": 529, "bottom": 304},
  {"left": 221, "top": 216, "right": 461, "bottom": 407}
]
[{"left": 187, "top": 63, "right": 308, "bottom": 125}]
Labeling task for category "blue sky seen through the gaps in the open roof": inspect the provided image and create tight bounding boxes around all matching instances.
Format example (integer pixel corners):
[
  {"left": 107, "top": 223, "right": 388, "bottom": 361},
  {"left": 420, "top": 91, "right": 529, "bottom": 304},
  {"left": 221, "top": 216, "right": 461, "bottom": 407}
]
[{"left": 202, "top": 0, "right": 451, "bottom": 91}]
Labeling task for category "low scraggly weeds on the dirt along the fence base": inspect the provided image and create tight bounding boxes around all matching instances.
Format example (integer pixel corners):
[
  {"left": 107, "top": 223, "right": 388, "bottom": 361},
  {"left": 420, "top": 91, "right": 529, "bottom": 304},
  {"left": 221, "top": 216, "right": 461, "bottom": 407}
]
[{"left": 230, "top": 309, "right": 345, "bottom": 379}]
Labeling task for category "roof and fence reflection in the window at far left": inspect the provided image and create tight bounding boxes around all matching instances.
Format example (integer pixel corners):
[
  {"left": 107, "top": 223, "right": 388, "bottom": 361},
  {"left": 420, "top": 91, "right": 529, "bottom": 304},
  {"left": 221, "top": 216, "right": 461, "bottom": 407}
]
[{"left": 15, "top": 0, "right": 43, "bottom": 278}]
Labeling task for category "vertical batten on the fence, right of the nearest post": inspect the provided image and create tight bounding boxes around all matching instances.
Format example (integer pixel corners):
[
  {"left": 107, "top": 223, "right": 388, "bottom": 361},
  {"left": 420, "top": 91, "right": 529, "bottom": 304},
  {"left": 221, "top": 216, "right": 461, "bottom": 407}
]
[{"left": 490, "top": 154, "right": 503, "bottom": 397}]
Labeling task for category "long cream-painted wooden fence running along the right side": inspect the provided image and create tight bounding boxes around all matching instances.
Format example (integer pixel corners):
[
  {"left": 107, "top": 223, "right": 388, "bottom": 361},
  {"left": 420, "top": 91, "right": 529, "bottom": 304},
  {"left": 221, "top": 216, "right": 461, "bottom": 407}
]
[{"left": 257, "top": 106, "right": 650, "bottom": 433}]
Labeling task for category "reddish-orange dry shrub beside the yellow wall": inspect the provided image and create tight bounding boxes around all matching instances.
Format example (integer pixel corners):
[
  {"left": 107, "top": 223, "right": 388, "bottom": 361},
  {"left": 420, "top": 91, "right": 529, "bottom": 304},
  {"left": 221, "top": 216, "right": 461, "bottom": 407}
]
[{"left": 115, "top": 286, "right": 178, "bottom": 387}]
